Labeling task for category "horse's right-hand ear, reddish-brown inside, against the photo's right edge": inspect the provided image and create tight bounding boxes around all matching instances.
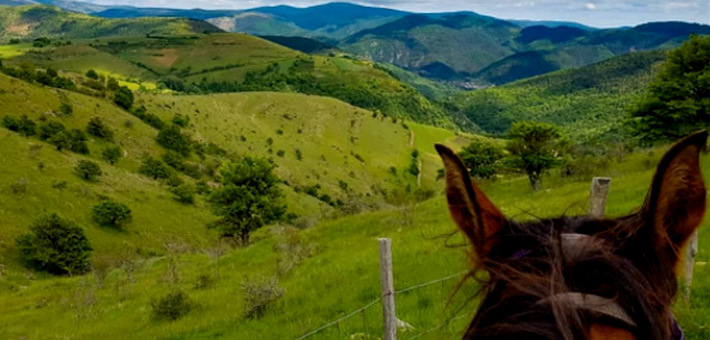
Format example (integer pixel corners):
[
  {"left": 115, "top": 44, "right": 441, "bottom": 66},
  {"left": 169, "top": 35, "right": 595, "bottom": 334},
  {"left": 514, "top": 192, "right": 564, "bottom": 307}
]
[{"left": 642, "top": 131, "right": 708, "bottom": 252}]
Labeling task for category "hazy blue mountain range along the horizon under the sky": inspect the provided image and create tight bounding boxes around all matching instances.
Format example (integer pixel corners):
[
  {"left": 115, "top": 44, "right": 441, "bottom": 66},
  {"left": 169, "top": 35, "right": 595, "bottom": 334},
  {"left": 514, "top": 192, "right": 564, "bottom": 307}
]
[{"left": 0, "top": 0, "right": 710, "bottom": 88}]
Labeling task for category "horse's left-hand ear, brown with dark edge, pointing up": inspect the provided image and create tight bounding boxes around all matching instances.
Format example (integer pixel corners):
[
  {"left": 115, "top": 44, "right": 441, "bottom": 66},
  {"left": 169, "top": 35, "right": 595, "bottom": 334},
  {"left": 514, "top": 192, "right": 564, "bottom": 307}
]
[{"left": 436, "top": 144, "right": 505, "bottom": 259}]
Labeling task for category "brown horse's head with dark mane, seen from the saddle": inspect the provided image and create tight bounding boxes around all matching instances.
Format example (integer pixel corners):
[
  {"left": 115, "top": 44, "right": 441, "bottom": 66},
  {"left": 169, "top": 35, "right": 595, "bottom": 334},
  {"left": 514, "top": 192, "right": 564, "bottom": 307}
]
[{"left": 436, "top": 132, "right": 708, "bottom": 340}]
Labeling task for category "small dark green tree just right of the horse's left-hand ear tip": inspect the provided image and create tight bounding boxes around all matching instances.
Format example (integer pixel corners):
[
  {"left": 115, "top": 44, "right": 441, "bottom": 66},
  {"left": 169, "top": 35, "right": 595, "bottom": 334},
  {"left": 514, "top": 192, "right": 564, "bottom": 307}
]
[{"left": 459, "top": 141, "right": 504, "bottom": 179}]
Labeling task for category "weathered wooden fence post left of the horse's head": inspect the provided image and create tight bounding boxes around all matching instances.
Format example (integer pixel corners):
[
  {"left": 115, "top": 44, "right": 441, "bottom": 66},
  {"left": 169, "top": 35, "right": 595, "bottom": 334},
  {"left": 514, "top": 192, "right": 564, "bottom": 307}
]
[{"left": 379, "top": 238, "right": 397, "bottom": 340}]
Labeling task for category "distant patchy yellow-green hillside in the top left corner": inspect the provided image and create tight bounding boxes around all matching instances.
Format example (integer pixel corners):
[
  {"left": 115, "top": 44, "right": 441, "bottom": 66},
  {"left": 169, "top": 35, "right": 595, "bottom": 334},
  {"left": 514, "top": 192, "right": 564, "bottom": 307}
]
[{"left": 0, "top": 5, "right": 220, "bottom": 41}]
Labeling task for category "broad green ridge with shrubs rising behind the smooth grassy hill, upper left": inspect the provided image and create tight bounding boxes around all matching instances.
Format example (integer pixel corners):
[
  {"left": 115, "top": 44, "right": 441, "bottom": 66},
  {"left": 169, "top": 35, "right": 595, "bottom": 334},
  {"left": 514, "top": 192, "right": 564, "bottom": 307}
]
[{"left": 0, "top": 33, "right": 455, "bottom": 128}]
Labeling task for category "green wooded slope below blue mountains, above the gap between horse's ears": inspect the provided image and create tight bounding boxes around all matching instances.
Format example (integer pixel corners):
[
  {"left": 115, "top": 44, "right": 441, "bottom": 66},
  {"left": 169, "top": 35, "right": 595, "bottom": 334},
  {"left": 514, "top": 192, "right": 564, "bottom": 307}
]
[{"left": 449, "top": 51, "right": 665, "bottom": 137}]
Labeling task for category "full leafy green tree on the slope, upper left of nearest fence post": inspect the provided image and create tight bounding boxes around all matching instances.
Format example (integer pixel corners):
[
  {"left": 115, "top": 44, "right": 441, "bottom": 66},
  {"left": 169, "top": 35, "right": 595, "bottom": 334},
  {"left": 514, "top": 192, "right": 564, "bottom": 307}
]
[{"left": 209, "top": 157, "right": 286, "bottom": 246}]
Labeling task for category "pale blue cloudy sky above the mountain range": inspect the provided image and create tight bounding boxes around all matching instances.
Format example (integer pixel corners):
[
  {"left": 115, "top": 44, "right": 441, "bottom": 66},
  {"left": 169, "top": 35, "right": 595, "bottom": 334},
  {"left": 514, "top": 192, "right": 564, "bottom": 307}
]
[{"left": 89, "top": 0, "right": 710, "bottom": 27}]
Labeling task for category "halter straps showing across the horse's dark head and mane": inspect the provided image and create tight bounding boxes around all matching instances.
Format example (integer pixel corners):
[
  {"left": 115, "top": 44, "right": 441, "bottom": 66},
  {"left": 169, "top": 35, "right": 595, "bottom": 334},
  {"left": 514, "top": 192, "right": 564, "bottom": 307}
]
[{"left": 511, "top": 233, "right": 685, "bottom": 340}]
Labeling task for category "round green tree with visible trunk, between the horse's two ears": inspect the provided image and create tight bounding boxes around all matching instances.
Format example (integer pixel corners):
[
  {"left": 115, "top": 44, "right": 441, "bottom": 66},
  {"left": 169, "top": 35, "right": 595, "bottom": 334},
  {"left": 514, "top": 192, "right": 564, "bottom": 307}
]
[{"left": 506, "top": 122, "right": 566, "bottom": 191}]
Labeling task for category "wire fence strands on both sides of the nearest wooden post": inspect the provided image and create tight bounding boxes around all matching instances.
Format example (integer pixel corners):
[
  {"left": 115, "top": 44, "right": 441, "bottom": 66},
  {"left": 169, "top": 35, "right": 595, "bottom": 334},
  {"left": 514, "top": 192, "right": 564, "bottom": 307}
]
[{"left": 295, "top": 271, "right": 470, "bottom": 340}]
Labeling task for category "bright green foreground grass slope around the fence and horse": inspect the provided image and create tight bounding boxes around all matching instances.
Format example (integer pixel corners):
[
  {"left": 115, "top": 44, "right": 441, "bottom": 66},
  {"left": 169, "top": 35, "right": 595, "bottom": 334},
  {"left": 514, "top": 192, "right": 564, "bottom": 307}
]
[{"left": 0, "top": 117, "right": 710, "bottom": 340}]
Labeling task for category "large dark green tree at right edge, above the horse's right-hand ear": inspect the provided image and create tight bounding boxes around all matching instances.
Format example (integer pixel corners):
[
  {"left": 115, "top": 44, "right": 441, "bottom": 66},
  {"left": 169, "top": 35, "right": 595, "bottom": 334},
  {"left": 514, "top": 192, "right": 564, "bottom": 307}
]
[{"left": 628, "top": 35, "right": 710, "bottom": 145}]
